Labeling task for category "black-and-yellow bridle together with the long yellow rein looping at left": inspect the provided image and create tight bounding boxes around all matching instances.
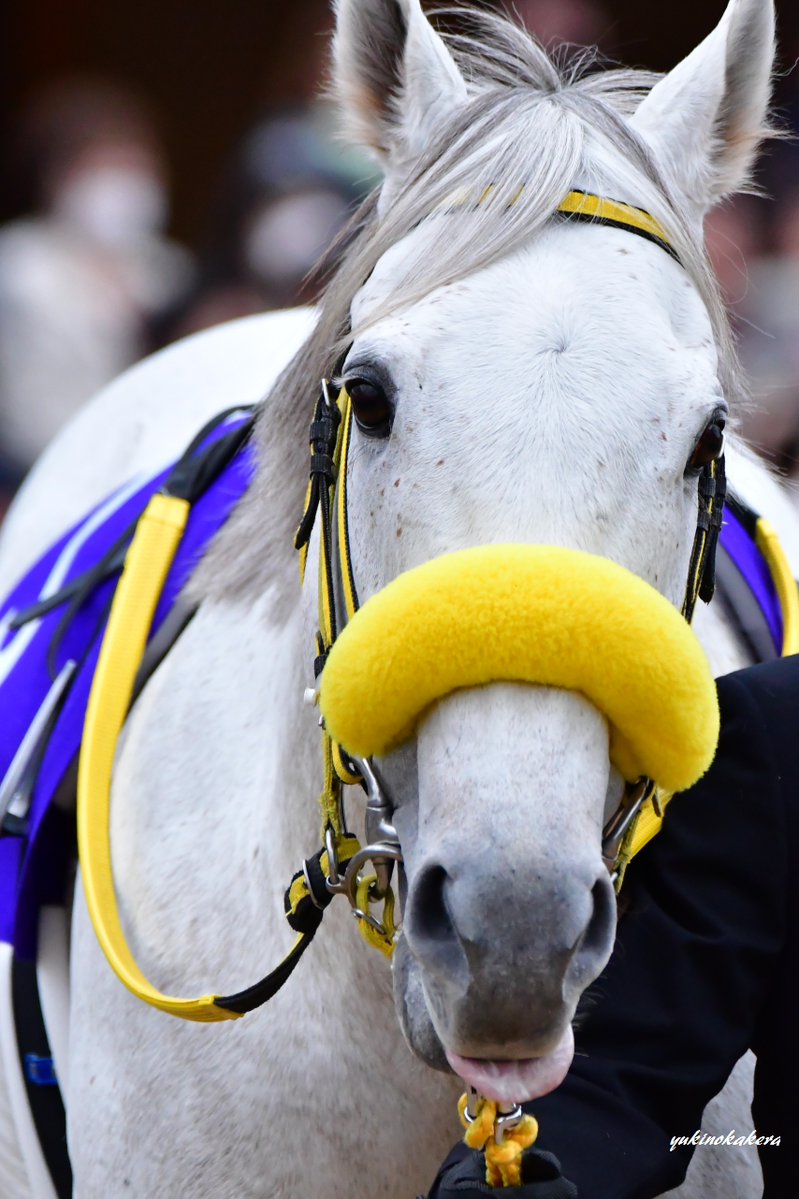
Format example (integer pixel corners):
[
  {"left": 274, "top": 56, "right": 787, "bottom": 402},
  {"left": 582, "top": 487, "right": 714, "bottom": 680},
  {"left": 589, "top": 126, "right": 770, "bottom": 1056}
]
[{"left": 78, "top": 189, "right": 725, "bottom": 1023}]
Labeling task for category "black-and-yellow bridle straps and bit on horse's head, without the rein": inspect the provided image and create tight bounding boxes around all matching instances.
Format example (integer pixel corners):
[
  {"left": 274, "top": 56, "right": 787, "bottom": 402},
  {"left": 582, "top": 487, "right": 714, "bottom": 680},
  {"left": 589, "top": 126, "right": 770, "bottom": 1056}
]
[{"left": 295, "top": 192, "right": 726, "bottom": 951}]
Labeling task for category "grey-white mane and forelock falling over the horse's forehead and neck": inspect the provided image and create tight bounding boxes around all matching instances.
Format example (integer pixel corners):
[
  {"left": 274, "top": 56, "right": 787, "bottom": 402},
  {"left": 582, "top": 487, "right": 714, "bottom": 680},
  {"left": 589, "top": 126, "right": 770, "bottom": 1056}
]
[{"left": 191, "top": 8, "right": 744, "bottom": 620}]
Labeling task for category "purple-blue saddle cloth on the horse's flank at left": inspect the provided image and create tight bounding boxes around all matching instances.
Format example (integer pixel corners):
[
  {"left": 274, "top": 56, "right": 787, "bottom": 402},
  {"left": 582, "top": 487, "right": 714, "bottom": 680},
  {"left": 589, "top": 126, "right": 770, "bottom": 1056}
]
[{"left": 0, "top": 420, "right": 254, "bottom": 959}]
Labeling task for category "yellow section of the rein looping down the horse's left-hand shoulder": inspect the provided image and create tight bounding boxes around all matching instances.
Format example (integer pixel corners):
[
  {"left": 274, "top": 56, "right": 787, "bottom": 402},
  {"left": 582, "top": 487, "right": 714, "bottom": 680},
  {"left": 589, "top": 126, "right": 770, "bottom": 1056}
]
[{"left": 78, "top": 495, "right": 240, "bottom": 1023}]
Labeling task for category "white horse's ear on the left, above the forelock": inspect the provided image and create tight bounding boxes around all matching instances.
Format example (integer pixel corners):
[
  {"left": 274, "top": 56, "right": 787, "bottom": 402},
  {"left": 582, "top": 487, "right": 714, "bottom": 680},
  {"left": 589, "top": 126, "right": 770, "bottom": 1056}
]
[{"left": 334, "top": 0, "right": 467, "bottom": 168}]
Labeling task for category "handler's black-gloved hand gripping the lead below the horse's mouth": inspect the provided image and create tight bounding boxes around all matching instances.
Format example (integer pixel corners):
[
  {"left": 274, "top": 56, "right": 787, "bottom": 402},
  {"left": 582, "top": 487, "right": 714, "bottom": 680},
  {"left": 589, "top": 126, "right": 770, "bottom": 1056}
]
[{"left": 419, "top": 1141, "right": 578, "bottom": 1199}]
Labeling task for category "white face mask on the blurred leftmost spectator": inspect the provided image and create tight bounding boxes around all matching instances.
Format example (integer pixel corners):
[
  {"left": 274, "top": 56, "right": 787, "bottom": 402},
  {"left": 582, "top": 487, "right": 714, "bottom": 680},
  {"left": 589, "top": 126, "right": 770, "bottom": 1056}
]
[{"left": 53, "top": 167, "right": 168, "bottom": 246}]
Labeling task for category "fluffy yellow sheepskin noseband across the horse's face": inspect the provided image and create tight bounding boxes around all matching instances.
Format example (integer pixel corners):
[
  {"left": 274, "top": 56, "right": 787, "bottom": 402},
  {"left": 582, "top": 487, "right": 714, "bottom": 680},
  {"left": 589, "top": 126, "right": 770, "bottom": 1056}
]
[{"left": 319, "top": 546, "right": 719, "bottom": 791}]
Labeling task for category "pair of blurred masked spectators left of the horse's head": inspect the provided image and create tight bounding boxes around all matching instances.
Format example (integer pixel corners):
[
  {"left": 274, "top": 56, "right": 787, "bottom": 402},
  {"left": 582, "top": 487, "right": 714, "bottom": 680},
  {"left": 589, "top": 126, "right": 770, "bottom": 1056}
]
[{"left": 0, "top": 79, "right": 374, "bottom": 505}]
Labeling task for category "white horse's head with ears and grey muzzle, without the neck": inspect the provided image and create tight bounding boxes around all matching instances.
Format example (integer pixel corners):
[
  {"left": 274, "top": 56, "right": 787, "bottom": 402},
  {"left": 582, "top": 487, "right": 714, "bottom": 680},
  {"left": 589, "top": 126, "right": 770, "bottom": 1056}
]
[{"left": 314, "top": 0, "right": 774, "bottom": 1099}]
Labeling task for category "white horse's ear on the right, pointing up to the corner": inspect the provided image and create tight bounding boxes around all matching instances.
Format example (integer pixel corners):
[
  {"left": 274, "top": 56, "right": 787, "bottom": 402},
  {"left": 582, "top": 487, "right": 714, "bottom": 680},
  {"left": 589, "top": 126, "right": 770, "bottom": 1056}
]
[{"left": 632, "top": 0, "right": 774, "bottom": 216}]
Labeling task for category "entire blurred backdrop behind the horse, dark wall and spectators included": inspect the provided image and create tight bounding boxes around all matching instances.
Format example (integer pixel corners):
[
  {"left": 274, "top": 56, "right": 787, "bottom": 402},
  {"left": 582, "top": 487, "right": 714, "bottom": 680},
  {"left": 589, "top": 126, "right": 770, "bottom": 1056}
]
[{"left": 0, "top": 0, "right": 799, "bottom": 511}]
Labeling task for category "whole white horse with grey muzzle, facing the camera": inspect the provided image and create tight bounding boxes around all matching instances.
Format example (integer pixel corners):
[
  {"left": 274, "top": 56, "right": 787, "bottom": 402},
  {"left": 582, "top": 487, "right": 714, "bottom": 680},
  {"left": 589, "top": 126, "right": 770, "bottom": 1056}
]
[{"left": 0, "top": 0, "right": 799, "bottom": 1199}]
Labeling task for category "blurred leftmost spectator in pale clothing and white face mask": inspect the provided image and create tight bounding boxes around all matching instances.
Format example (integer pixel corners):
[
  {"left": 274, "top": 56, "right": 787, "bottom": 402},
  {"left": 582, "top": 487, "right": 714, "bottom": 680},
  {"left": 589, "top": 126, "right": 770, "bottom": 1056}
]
[{"left": 0, "top": 82, "right": 193, "bottom": 486}]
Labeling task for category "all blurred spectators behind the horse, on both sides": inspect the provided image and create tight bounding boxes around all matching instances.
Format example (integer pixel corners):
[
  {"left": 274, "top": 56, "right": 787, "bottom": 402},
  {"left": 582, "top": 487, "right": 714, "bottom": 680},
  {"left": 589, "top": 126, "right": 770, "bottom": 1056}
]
[{"left": 0, "top": 0, "right": 799, "bottom": 511}]
